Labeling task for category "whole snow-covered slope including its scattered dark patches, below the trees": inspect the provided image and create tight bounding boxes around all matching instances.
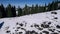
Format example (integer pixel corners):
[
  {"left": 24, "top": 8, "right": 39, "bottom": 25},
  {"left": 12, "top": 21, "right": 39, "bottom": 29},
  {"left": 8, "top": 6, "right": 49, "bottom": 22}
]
[{"left": 0, "top": 10, "right": 60, "bottom": 34}]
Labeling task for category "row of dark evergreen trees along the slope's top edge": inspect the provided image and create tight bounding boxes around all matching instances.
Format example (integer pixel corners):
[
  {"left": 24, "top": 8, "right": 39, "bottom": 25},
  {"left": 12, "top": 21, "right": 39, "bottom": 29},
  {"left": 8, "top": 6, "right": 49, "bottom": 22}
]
[{"left": 0, "top": 1, "right": 60, "bottom": 18}]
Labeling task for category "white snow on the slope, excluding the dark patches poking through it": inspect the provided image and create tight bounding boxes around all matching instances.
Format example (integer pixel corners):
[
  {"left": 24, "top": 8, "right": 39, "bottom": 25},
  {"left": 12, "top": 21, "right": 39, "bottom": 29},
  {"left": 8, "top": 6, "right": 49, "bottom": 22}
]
[{"left": 0, "top": 10, "right": 60, "bottom": 34}]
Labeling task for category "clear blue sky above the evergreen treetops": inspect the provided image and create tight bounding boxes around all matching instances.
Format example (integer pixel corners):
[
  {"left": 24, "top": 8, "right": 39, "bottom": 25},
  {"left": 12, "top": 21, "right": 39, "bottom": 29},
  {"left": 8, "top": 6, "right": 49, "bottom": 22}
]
[{"left": 0, "top": 0, "right": 59, "bottom": 7}]
